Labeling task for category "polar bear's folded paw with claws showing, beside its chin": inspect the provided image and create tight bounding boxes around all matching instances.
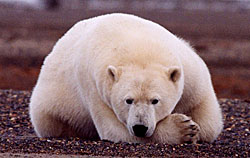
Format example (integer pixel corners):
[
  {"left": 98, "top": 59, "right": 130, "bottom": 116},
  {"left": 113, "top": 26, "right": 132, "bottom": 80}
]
[{"left": 152, "top": 113, "right": 200, "bottom": 144}]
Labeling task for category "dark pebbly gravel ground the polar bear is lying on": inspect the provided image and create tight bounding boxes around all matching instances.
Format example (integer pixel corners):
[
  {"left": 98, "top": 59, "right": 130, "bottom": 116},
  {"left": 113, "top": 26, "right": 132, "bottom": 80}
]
[{"left": 0, "top": 90, "right": 250, "bottom": 157}]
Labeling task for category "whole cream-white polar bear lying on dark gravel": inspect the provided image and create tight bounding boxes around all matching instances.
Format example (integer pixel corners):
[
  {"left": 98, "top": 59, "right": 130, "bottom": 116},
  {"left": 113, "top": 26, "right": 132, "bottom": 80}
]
[{"left": 29, "top": 13, "right": 223, "bottom": 144}]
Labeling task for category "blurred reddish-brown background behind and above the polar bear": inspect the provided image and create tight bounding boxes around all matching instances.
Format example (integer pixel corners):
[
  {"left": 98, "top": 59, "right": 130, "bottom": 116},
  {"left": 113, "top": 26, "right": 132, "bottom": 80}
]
[{"left": 0, "top": 0, "right": 250, "bottom": 98}]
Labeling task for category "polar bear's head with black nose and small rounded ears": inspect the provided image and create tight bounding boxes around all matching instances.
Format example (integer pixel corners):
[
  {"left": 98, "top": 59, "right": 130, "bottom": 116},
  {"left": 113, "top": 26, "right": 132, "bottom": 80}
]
[{"left": 107, "top": 65, "right": 184, "bottom": 137}]
